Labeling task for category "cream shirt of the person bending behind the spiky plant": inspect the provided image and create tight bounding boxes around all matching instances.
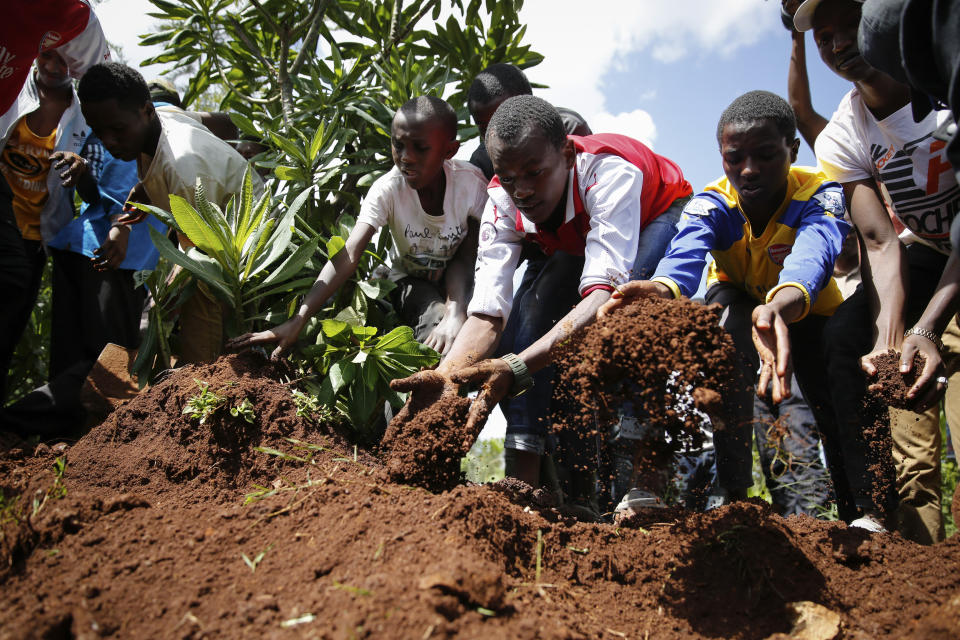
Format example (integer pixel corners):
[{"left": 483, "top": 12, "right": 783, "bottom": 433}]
[{"left": 137, "top": 109, "right": 263, "bottom": 211}]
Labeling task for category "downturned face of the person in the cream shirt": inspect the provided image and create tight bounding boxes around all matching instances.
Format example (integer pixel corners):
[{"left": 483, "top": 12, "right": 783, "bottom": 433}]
[{"left": 80, "top": 98, "right": 156, "bottom": 161}]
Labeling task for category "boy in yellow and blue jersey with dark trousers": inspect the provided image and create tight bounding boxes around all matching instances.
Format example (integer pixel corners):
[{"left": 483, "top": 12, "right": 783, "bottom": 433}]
[{"left": 601, "top": 91, "right": 880, "bottom": 520}]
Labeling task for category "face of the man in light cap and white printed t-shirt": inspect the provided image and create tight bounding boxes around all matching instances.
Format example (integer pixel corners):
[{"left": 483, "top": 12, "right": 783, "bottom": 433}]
[{"left": 813, "top": 0, "right": 876, "bottom": 82}]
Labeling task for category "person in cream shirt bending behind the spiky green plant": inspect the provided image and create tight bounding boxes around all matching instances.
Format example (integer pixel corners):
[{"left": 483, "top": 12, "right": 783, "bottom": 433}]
[{"left": 78, "top": 62, "right": 262, "bottom": 364}]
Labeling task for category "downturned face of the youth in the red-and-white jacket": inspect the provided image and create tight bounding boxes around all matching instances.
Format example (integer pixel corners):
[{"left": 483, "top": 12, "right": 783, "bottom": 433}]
[{"left": 487, "top": 127, "right": 576, "bottom": 224}]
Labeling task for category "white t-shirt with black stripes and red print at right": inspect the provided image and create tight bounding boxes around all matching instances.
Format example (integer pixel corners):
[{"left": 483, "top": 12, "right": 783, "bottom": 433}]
[{"left": 816, "top": 89, "right": 960, "bottom": 254}]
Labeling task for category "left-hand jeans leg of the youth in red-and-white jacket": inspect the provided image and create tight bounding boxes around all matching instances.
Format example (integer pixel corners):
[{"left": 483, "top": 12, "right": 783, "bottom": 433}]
[{"left": 497, "top": 251, "right": 583, "bottom": 479}]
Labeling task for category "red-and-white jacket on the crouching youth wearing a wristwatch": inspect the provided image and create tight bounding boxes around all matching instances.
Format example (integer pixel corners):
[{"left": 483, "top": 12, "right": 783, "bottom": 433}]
[{"left": 468, "top": 133, "right": 693, "bottom": 318}]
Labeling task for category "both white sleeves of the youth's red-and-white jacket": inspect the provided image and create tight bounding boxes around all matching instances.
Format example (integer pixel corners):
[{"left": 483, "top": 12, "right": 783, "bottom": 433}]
[{"left": 467, "top": 152, "right": 643, "bottom": 319}]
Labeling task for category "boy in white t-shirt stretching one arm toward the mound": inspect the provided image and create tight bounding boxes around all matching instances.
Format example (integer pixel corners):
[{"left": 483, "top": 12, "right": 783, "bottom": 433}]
[{"left": 227, "top": 96, "right": 487, "bottom": 357}]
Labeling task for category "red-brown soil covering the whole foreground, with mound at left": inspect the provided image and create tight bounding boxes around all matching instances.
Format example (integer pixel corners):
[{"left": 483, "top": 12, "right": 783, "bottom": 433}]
[{"left": 0, "top": 356, "right": 960, "bottom": 639}]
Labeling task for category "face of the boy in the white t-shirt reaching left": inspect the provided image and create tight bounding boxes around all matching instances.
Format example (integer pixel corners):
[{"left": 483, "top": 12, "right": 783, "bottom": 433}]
[{"left": 390, "top": 111, "right": 460, "bottom": 189}]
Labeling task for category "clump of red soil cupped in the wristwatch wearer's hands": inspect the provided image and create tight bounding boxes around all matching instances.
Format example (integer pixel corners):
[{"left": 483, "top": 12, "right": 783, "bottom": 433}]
[{"left": 381, "top": 380, "right": 474, "bottom": 491}]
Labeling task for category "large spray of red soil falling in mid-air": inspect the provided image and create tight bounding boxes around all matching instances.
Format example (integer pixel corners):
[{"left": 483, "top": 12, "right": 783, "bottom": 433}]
[{"left": 553, "top": 298, "right": 738, "bottom": 482}]
